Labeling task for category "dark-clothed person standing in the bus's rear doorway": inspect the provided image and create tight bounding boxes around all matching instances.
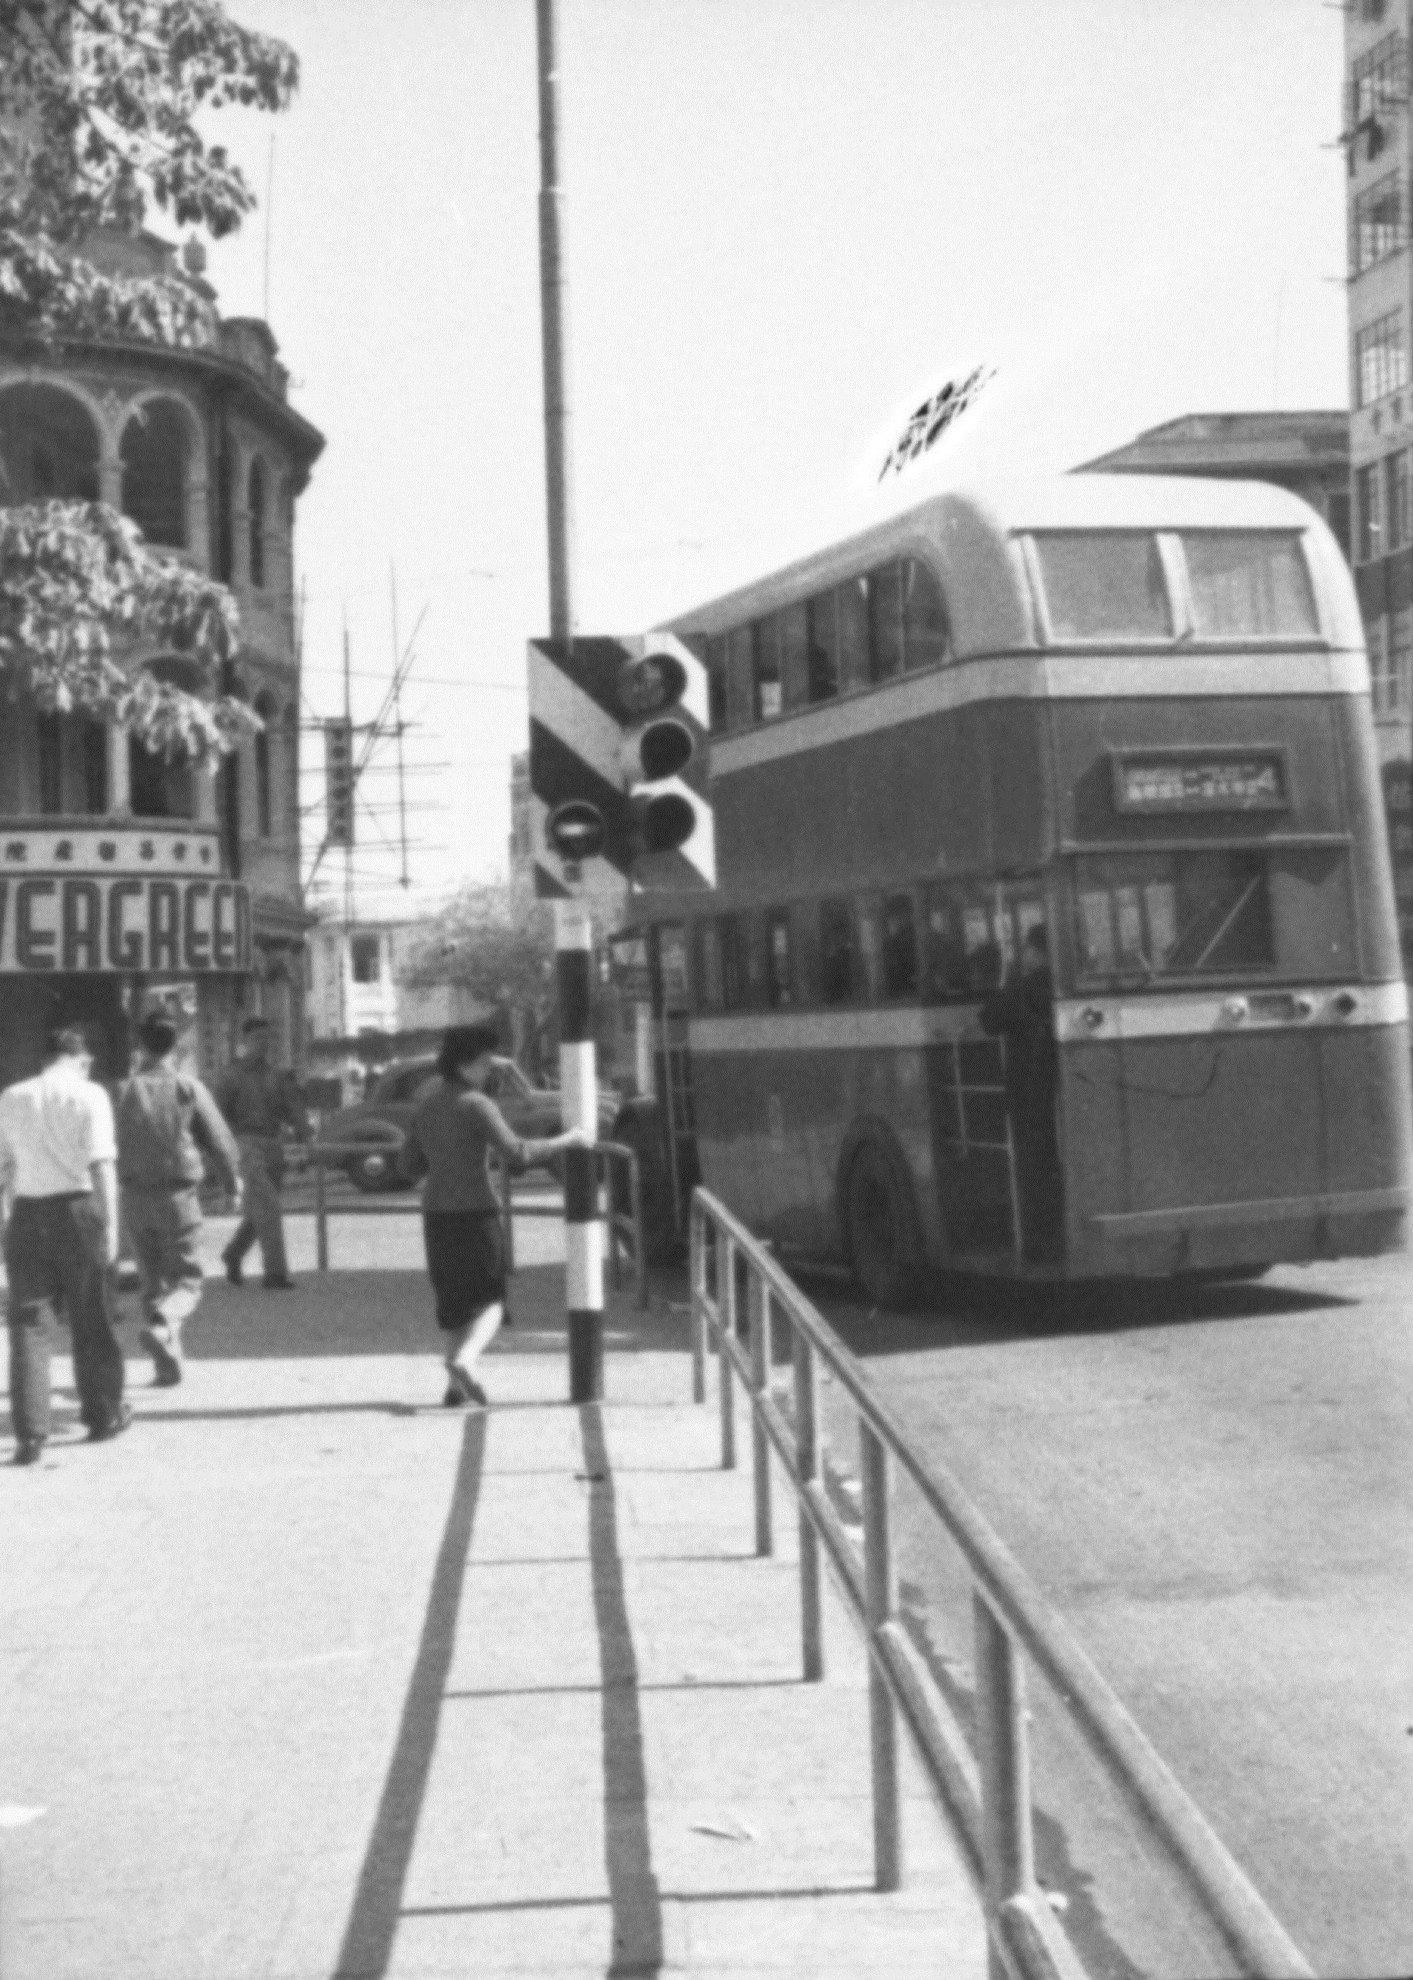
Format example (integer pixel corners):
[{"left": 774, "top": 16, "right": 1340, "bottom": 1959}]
[{"left": 980, "top": 927, "right": 1065, "bottom": 1265}]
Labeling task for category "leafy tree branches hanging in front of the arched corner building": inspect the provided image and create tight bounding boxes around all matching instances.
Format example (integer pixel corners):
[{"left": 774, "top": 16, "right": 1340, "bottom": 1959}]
[{"left": 0, "top": 0, "right": 299, "bottom": 760}]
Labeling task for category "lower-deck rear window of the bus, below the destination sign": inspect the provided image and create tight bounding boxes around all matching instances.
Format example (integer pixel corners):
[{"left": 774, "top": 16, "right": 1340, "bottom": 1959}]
[{"left": 1077, "top": 851, "right": 1274, "bottom": 976}]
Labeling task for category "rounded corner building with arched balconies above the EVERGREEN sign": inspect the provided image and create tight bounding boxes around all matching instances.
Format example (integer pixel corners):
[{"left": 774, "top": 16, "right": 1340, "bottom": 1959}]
[{"left": 0, "top": 236, "right": 323, "bottom": 1085}]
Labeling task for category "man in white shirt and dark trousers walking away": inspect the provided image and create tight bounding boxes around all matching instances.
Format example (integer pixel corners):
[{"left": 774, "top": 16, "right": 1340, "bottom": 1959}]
[{"left": 0, "top": 1026, "right": 133, "bottom": 1465}]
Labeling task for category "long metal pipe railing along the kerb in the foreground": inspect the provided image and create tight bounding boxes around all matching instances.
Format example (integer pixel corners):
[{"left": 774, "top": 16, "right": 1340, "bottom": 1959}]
[{"left": 691, "top": 1190, "right": 1310, "bottom": 1980}]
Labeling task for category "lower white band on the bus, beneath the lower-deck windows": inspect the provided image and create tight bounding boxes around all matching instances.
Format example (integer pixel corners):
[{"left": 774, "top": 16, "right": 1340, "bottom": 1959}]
[{"left": 687, "top": 982, "right": 1409, "bottom": 1053}]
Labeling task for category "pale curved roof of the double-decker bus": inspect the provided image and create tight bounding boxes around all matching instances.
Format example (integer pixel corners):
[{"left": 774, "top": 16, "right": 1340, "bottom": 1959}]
[{"left": 665, "top": 475, "right": 1324, "bottom": 657}]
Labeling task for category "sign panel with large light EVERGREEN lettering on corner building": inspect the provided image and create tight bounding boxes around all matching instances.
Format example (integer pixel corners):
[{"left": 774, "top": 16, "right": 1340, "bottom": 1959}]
[{"left": 0, "top": 873, "right": 251, "bottom": 976}]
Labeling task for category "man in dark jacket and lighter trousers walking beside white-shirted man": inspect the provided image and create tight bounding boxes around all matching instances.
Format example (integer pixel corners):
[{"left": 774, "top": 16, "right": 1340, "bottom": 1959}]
[{"left": 117, "top": 1012, "right": 239, "bottom": 1388}]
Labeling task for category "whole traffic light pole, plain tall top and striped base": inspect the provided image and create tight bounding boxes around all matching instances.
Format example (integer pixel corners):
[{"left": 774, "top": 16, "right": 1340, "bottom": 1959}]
[{"left": 534, "top": 0, "right": 604, "bottom": 1402}]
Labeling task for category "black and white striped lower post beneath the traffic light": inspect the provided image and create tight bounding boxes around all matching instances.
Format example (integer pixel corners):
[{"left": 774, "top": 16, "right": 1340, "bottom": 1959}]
[{"left": 554, "top": 899, "right": 604, "bottom": 1402}]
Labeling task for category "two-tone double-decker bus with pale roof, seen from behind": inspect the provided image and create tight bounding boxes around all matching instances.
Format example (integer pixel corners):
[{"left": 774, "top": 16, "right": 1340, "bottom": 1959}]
[{"left": 637, "top": 475, "right": 1413, "bottom": 1303}]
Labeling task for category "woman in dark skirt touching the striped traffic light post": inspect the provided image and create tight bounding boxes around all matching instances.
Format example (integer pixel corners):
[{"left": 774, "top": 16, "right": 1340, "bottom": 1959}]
[{"left": 400, "top": 1024, "right": 588, "bottom": 1406}]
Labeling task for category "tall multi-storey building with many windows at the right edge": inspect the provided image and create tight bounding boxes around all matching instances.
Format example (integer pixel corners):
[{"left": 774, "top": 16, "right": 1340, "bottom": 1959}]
[{"left": 1342, "top": 0, "right": 1413, "bottom": 968}]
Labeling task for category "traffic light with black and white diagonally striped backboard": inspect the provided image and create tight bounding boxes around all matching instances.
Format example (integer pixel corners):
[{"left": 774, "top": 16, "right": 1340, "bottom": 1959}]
[{"left": 526, "top": 634, "right": 716, "bottom": 895}]
